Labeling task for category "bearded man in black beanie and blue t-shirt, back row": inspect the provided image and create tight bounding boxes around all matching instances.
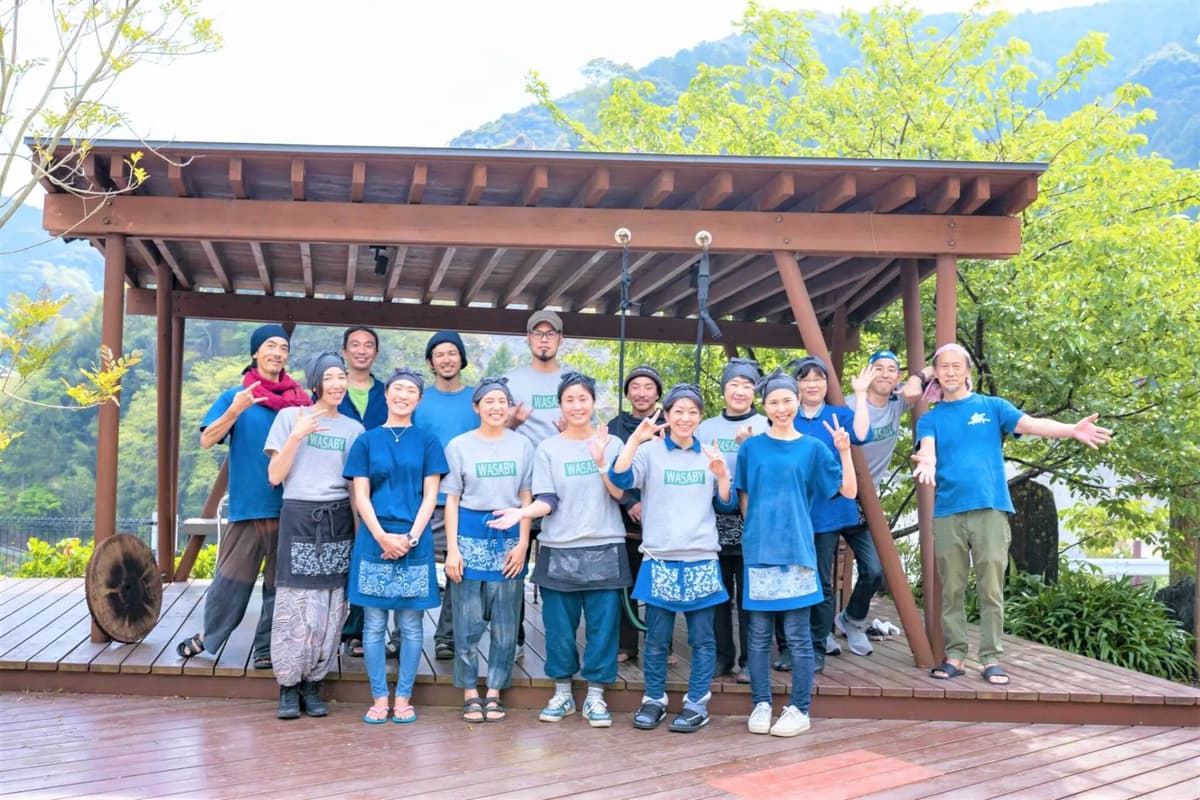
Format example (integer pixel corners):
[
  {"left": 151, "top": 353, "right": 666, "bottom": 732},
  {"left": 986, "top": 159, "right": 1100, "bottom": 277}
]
[{"left": 413, "top": 331, "right": 479, "bottom": 661}]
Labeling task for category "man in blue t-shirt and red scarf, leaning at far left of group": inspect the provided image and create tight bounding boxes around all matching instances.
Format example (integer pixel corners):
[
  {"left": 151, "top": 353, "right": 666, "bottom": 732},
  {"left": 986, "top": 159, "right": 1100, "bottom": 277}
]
[{"left": 175, "top": 325, "right": 312, "bottom": 669}]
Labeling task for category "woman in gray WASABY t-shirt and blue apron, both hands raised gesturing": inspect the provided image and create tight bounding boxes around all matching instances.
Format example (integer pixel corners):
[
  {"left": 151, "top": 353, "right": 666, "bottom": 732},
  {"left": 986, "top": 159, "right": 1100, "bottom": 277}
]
[{"left": 608, "top": 384, "right": 737, "bottom": 733}]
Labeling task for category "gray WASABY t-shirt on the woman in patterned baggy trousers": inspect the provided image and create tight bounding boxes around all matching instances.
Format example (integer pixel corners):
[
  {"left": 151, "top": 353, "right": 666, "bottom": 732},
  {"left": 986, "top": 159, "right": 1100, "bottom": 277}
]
[{"left": 263, "top": 407, "right": 364, "bottom": 503}]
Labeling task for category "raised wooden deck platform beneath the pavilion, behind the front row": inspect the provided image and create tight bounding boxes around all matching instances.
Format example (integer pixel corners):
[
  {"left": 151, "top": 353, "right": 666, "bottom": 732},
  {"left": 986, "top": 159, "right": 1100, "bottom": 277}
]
[{"left": 0, "top": 578, "right": 1200, "bottom": 727}]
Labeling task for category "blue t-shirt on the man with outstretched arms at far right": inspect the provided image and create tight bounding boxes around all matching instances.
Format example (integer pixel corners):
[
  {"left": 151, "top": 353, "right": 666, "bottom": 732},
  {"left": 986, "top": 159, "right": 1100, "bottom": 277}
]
[{"left": 917, "top": 393, "right": 1025, "bottom": 517}]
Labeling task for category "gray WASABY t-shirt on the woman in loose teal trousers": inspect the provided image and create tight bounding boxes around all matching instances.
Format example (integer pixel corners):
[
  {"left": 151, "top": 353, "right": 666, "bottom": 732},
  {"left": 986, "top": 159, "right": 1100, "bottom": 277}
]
[{"left": 533, "top": 434, "right": 625, "bottom": 547}]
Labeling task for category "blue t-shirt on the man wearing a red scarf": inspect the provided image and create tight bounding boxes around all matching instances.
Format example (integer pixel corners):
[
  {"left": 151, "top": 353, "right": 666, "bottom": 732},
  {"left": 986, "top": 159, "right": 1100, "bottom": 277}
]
[{"left": 200, "top": 386, "right": 283, "bottom": 522}]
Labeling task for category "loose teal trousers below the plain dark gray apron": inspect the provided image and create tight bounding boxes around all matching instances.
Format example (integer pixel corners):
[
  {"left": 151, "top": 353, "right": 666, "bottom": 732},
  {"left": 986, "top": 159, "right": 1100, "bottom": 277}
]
[{"left": 541, "top": 588, "right": 622, "bottom": 684}]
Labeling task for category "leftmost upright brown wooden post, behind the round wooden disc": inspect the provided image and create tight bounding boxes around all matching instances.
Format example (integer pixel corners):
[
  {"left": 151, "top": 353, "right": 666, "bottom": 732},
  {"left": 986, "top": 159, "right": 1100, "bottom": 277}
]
[{"left": 91, "top": 234, "right": 125, "bottom": 642}]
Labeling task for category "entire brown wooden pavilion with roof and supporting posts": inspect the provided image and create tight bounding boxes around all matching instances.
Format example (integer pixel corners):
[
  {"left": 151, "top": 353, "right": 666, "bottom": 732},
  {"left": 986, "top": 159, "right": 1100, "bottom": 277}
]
[{"left": 28, "top": 140, "right": 1044, "bottom": 668}]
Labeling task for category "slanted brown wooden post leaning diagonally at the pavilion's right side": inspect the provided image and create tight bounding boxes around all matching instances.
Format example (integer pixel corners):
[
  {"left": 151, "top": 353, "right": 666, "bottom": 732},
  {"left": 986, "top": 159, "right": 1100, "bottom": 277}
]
[{"left": 774, "top": 251, "right": 935, "bottom": 669}]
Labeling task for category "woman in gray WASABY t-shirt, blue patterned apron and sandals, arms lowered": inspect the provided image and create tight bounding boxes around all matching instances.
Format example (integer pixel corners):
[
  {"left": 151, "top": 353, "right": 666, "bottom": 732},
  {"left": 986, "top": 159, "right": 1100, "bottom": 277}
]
[{"left": 442, "top": 378, "right": 533, "bottom": 722}]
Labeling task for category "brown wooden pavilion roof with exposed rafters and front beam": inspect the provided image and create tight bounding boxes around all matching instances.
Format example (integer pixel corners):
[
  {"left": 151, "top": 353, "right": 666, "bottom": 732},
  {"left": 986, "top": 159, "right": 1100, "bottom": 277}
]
[{"left": 35, "top": 140, "right": 1045, "bottom": 343}]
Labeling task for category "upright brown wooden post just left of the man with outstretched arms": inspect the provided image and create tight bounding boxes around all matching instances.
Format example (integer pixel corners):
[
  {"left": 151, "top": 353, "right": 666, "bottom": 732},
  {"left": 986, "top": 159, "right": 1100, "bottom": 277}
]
[{"left": 900, "top": 259, "right": 946, "bottom": 655}]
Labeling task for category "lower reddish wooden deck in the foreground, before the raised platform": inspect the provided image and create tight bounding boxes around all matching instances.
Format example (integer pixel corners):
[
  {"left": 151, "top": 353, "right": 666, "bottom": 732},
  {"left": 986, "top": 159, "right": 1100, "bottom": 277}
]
[{"left": 0, "top": 681, "right": 1200, "bottom": 800}]
